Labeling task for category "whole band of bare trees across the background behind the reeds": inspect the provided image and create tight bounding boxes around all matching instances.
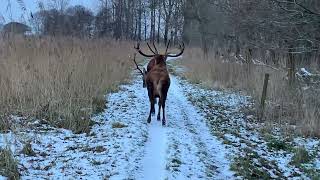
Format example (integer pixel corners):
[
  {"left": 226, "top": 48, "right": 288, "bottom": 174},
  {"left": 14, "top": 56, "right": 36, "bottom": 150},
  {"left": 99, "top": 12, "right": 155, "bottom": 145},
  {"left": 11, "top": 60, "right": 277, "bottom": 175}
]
[{"left": 8, "top": 0, "right": 320, "bottom": 65}]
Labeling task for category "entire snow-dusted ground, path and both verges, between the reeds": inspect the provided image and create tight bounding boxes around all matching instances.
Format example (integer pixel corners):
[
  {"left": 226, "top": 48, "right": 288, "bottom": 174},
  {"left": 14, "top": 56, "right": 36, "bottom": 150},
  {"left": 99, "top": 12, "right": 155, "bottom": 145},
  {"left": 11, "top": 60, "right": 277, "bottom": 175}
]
[{"left": 0, "top": 59, "right": 320, "bottom": 179}]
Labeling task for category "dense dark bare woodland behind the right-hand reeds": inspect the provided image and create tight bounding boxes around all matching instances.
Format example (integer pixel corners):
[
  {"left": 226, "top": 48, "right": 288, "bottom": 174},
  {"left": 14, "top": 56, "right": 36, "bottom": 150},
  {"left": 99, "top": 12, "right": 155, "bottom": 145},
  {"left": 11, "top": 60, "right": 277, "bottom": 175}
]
[{"left": 184, "top": 0, "right": 320, "bottom": 66}]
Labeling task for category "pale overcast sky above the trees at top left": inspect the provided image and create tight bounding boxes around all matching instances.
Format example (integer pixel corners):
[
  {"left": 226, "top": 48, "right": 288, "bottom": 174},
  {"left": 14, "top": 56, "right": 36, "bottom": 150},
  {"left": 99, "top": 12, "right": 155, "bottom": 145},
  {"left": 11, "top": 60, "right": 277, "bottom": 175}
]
[{"left": 0, "top": 0, "right": 99, "bottom": 23}]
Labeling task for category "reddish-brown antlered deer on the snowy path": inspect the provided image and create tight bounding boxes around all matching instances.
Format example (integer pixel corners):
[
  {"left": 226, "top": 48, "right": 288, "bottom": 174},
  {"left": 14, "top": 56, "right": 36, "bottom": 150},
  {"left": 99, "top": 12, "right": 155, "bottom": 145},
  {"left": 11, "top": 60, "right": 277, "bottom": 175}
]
[{"left": 134, "top": 41, "right": 184, "bottom": 126}]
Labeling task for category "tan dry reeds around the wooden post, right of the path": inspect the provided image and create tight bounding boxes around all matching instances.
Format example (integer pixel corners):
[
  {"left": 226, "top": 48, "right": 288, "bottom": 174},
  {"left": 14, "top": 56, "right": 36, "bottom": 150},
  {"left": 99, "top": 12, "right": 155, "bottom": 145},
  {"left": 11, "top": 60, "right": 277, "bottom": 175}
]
[{"left": 181, "top": 48, "right": 320, "bottom": 136}]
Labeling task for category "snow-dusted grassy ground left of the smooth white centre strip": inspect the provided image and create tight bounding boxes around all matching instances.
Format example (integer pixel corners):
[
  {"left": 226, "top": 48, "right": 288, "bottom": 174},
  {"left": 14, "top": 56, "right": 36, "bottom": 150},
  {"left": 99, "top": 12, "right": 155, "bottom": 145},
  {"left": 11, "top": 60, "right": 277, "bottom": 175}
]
[{"left": 0, "top": 76, "right": 147, "bottom": 179}]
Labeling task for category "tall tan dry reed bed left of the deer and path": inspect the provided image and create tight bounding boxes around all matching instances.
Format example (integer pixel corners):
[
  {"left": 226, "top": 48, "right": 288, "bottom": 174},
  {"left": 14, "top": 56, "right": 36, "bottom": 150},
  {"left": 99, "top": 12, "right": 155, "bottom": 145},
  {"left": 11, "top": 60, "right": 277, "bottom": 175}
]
[{"left": 0, "top": 37, "right": 133, "bottom": 134}]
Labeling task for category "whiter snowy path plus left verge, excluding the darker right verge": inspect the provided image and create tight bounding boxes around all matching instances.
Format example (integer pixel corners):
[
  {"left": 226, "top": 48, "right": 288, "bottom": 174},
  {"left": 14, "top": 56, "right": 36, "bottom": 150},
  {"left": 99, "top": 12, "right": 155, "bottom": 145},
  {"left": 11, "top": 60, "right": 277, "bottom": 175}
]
[{"left": 0, "top": 67, "right": 233, "bottom": 179}]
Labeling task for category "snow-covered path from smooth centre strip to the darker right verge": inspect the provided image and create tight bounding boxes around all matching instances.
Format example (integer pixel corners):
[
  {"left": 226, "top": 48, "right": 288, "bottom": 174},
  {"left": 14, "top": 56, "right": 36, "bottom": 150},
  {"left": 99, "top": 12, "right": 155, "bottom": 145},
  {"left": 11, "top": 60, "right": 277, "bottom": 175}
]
[{"left": 129, "top": 76, "right": 233, "bottom": 179}]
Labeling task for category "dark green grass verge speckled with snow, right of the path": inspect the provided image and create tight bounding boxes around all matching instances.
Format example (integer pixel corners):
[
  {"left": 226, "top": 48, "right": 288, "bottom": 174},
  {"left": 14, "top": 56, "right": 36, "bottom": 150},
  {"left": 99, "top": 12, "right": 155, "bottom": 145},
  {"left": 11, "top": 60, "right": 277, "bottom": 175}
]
[{"left": 175, "top": 68, "right": 320, "bottom": 179}]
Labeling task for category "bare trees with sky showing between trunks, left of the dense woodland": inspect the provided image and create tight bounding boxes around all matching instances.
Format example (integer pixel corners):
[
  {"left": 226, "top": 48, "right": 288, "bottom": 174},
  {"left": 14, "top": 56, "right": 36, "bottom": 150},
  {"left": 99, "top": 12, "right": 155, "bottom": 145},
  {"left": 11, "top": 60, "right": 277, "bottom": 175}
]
[{"left": 31, "top": 0, "right": 184, "bottom": 42}]
